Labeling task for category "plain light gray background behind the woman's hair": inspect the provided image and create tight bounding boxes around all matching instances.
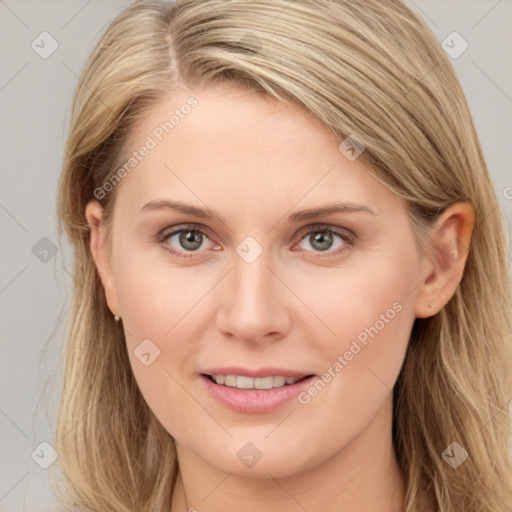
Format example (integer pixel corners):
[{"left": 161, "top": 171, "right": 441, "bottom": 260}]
[{"left": 0, "top": 0, "right": 512, "bottom": 512}]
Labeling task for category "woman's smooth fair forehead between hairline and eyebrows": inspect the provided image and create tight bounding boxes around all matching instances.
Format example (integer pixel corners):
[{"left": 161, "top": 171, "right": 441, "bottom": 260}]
[{"left": 114, "top": 85, "right": 401, "bottom": 220}]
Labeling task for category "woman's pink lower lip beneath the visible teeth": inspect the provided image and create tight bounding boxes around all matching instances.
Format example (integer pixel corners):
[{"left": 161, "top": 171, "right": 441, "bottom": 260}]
[{"left": 201, "top": 375, "right": 314, "bottom": 414}]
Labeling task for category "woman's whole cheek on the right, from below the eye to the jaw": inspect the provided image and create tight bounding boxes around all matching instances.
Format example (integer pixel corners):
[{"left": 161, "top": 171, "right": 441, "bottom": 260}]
[{"left": 299, "top": 251, "right": 416, "bottom": 432}]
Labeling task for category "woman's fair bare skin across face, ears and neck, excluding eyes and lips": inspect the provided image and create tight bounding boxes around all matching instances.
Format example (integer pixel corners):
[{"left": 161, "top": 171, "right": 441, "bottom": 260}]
[{"left": 86, "top": 85, "right": 474, "bottom": 512}]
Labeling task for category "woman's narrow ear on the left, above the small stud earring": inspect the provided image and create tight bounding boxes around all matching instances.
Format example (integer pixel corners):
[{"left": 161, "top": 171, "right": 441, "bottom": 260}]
[{"left": 85, "top": 199, "right": 121, "bottom": 316}]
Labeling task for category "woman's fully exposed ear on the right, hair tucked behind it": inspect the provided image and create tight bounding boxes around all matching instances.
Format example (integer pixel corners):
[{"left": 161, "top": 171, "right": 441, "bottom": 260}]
[{"left": 415, "top": 203, "right": 475, "bottom": 318}]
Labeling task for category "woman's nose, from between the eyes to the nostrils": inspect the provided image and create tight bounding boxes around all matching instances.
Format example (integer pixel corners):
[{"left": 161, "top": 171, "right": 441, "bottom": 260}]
[{"left": 217, "top": 251, "right": 293, "bottom": 343}]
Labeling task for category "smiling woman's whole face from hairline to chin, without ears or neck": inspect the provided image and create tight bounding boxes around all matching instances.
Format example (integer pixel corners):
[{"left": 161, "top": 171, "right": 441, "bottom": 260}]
[{"left": 88, "top": 86, "right": 424, "bottom": 477}]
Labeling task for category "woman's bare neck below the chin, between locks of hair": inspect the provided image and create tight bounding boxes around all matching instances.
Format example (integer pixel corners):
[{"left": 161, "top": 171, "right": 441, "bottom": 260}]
[{"left": 171, "top": 399, "right": 405, "bottom": 512}]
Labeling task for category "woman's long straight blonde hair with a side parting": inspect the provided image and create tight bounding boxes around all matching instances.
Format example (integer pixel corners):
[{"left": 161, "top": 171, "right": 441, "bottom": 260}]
[{"left": 55, "top": 0, "right": 512, "bottom": 512}]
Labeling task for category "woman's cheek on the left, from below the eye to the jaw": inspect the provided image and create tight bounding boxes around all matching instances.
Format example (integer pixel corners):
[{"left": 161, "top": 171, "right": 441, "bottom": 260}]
[{"left": 111, "top": 252, "right": 215, "bottom": 432}]
